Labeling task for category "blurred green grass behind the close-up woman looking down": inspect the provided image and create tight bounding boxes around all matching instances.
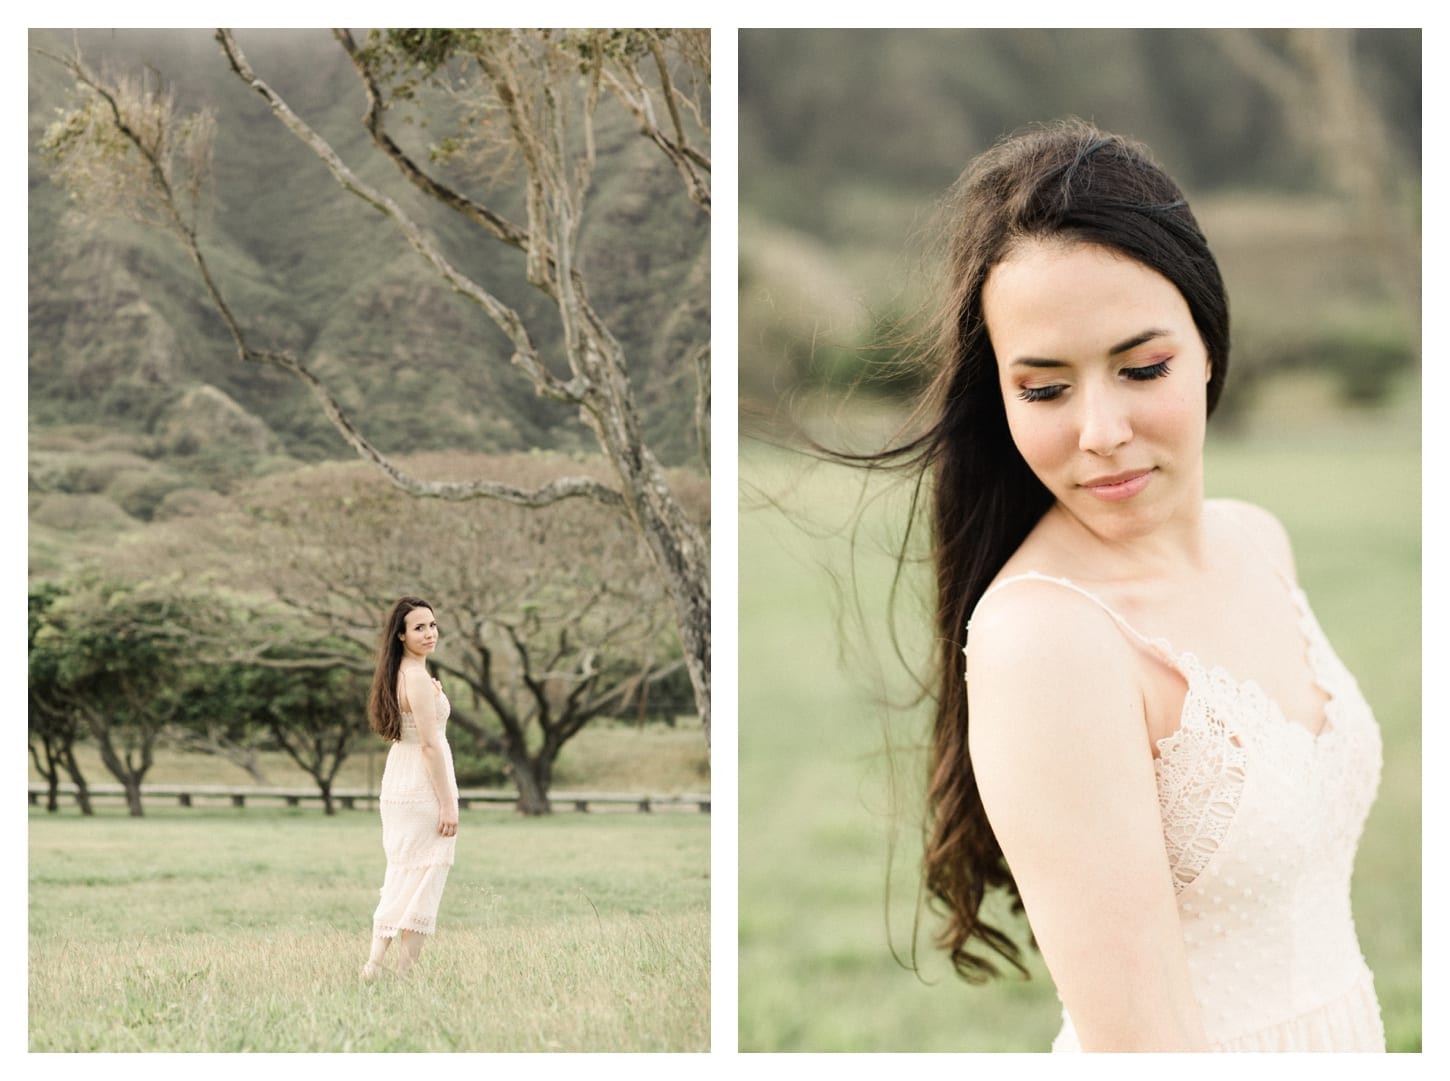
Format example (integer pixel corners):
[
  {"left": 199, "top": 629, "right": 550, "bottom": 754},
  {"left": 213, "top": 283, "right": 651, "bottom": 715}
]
[{"left": 738, "top": 387, "right": 1421, "bottom": 1051}]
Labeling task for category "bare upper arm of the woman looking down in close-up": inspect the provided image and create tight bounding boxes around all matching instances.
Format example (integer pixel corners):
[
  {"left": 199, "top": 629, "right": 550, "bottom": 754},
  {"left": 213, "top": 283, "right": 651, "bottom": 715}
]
[{"left": 967, "top": 583, "right": 1208, "bottom": 1051}]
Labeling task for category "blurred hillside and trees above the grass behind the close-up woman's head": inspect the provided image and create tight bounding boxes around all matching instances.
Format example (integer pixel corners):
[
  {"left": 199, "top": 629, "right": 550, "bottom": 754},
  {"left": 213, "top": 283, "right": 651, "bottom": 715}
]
[{"left": 740, "top": 30, "right": 1421, "bottom": 423}]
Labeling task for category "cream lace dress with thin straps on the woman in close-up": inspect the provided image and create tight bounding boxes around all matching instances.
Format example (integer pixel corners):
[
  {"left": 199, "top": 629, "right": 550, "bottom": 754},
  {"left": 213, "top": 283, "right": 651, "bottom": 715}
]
[{"left": 990, "top": 572, "right": 1385, "bottom": 1051}]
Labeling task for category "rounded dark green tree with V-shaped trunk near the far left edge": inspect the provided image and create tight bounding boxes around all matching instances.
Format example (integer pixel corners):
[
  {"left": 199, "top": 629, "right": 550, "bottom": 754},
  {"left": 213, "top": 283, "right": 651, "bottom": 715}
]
[{"left": 30, "top": 583, "right": 191, "bottom": 816}]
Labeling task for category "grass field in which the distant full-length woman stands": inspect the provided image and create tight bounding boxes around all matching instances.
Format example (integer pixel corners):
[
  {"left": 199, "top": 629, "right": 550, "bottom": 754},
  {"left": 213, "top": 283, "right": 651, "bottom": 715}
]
[{"left": 29, "top": 807, "right": 711, "bottom": 1052}]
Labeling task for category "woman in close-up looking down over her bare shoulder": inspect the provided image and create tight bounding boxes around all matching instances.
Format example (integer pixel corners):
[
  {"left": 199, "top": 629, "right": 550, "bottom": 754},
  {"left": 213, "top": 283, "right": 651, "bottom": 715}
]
[{"left": 879, "top": 122, "right": 1385, "bottom": 1051}]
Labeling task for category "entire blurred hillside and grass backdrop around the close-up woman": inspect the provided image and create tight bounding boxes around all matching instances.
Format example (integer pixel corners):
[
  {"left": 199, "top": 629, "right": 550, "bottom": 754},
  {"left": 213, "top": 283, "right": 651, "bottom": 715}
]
[{"left": 738, "top": 30, "right": 1421, "bottom": 1051}]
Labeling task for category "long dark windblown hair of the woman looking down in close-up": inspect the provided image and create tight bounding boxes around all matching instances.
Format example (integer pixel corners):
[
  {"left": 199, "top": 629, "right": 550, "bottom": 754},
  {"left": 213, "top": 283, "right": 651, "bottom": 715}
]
[{"left": 857, "top": 120, "right": 1228, "bottom": 982}]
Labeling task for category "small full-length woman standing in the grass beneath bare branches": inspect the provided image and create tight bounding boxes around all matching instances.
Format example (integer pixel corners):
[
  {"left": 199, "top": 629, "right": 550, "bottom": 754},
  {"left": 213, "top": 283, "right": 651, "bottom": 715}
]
[{"left": 361, "top": 597, "right": 458, "bottom": 981}]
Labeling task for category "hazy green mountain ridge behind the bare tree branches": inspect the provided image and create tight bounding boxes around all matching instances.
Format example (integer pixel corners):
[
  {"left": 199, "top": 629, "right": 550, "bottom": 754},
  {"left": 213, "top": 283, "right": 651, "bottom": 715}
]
[{"left": 29, "top": 30, "right": 709, "bottom": 501}]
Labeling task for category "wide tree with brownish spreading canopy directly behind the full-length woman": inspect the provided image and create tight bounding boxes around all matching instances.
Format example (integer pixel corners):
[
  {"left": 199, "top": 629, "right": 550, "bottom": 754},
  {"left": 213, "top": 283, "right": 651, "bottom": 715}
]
[{"left": 128, "top": 454, "right": 706, "bottom": 814}]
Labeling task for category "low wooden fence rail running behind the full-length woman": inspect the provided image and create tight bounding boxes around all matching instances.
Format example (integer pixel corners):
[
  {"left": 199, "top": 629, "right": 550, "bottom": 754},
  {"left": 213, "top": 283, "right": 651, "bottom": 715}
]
[{"left": 30, "top": 784, "right": 711, "bottom": 814}]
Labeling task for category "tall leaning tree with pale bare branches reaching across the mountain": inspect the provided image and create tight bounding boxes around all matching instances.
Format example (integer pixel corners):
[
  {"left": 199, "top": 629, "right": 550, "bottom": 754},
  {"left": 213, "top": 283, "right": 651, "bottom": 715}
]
[{"left": 35, "top": 30, "right": 711, "bottom": 742}]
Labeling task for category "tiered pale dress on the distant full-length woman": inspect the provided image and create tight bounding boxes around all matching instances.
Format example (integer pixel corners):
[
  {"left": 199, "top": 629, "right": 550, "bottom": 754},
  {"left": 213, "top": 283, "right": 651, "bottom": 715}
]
[{"left": 373, "top": 690, "right": 458, "bottom": 938}]
